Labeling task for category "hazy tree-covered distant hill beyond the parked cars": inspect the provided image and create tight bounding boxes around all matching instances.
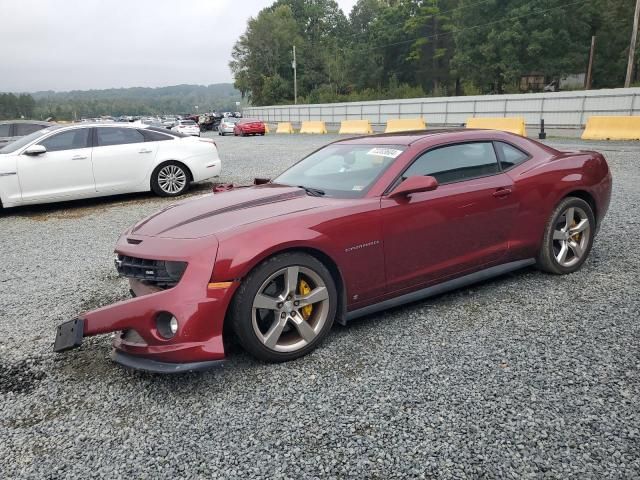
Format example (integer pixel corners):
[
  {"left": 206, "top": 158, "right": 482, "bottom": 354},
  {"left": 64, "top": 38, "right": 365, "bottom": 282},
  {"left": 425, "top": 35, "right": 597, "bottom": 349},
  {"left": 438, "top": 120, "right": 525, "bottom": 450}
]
[{"left": 31, "top": 83, "right": 240, "bottom": 120}]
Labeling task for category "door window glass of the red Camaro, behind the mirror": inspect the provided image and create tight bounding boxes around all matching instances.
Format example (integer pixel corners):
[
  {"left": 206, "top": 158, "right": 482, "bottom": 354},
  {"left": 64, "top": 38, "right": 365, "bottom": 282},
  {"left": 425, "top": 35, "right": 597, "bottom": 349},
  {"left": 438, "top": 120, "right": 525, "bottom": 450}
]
[{"left": 402, "top": 142, "right": 499, "bottom": 183}]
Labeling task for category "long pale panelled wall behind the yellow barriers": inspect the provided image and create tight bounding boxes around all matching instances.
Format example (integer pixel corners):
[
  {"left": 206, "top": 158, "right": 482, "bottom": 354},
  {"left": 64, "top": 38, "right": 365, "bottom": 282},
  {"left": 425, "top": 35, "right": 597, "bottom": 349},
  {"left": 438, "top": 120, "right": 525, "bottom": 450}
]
[{"left": 243, "top": 88, "right": 640, "bottom": 128}]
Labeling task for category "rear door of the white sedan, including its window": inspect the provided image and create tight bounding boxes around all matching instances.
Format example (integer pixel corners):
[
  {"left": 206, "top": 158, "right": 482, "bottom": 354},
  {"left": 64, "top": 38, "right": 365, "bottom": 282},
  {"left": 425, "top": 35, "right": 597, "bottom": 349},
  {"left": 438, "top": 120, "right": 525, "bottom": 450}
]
[{"left": 93, "top": 126, "right": 158, "bottom": 193}]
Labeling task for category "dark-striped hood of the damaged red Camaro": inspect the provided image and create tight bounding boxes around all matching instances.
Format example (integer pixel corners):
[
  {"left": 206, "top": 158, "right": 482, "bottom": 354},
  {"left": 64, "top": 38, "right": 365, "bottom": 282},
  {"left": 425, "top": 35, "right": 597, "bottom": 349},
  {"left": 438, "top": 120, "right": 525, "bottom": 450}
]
[{"left": 128, "top": 184, "right": 327, "bottom": 239}]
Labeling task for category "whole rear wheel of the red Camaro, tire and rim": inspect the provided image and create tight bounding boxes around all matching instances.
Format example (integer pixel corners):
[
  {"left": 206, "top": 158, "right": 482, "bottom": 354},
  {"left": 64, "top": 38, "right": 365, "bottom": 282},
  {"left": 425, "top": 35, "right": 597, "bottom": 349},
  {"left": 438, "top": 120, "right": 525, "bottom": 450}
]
[{"left": 537, "top": 197, "right": 596, "bottom": 275}]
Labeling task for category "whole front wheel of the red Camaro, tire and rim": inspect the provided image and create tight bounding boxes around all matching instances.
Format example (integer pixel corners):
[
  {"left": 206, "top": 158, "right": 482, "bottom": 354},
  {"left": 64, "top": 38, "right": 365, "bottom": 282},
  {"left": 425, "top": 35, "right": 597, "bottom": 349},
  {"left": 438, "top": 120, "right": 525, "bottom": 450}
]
[{"left": 231, "top": 253, "right": 338, "bottom": 362}]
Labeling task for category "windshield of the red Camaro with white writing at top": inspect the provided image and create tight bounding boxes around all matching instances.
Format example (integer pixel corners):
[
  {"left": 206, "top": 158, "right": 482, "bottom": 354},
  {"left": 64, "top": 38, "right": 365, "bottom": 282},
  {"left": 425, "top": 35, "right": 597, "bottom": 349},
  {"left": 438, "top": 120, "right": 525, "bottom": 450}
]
[{"left": 273, "top": 144, "right": 406, "bottom": 198}]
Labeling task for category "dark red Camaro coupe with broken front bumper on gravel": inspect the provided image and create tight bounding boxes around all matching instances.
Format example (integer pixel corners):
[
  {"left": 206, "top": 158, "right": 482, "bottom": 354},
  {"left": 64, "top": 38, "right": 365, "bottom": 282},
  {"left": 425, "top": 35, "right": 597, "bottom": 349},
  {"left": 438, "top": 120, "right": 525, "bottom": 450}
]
[{"left": 54, "top": 130, "right": 611, "bottom": 372}]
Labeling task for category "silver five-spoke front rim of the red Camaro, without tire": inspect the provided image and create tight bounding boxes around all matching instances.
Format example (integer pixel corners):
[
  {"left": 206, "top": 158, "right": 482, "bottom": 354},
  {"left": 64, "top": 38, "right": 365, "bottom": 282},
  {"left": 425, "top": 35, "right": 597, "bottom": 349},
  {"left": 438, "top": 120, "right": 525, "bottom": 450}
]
[{"left": 251, "top": 265, "right": 329, "bottom": 352}]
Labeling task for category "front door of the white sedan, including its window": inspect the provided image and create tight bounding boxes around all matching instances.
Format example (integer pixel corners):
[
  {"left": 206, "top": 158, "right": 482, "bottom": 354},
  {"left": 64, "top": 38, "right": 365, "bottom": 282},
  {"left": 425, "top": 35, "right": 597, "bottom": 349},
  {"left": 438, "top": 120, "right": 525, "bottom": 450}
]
[{"left": 18, "top": 128, "right": 95, "bottom": 203}]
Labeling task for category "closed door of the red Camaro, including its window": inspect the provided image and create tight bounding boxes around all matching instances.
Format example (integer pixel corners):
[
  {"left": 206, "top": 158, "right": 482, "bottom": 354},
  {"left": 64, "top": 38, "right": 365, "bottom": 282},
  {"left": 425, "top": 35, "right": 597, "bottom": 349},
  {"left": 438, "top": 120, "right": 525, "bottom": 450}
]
[{"left": 381, "top": 142, "right": 517, "bottom": 291}]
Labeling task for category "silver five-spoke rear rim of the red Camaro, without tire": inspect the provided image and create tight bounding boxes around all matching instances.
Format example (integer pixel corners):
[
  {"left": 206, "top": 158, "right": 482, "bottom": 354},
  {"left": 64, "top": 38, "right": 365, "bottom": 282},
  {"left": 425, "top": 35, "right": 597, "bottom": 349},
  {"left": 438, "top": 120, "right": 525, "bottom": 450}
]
[{"left": 553, "top": 207, "right": 591, "bottom": 267}]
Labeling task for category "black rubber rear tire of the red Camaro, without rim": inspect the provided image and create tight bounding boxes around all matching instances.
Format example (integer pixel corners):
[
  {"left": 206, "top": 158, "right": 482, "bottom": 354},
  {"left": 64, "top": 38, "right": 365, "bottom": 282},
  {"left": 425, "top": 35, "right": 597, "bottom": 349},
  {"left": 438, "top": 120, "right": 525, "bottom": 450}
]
[{"left": 536, "top": 197, "right": 596, "bottom": 275}]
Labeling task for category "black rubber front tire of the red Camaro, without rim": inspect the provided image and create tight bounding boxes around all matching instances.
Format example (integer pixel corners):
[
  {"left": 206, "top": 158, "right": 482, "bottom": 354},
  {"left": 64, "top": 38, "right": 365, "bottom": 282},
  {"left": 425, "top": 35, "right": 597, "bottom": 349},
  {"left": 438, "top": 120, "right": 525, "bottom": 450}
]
[{"left": 230, "top": 252, "right": 338, "bottom": 362}]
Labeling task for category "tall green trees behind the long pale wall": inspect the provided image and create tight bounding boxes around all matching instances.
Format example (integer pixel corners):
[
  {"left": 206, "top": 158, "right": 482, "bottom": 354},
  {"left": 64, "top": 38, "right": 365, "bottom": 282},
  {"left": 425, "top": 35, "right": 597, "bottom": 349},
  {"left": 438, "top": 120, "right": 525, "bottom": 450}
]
[{"left": 231, "top": 0, "right": 637, "bottom": 105}]
